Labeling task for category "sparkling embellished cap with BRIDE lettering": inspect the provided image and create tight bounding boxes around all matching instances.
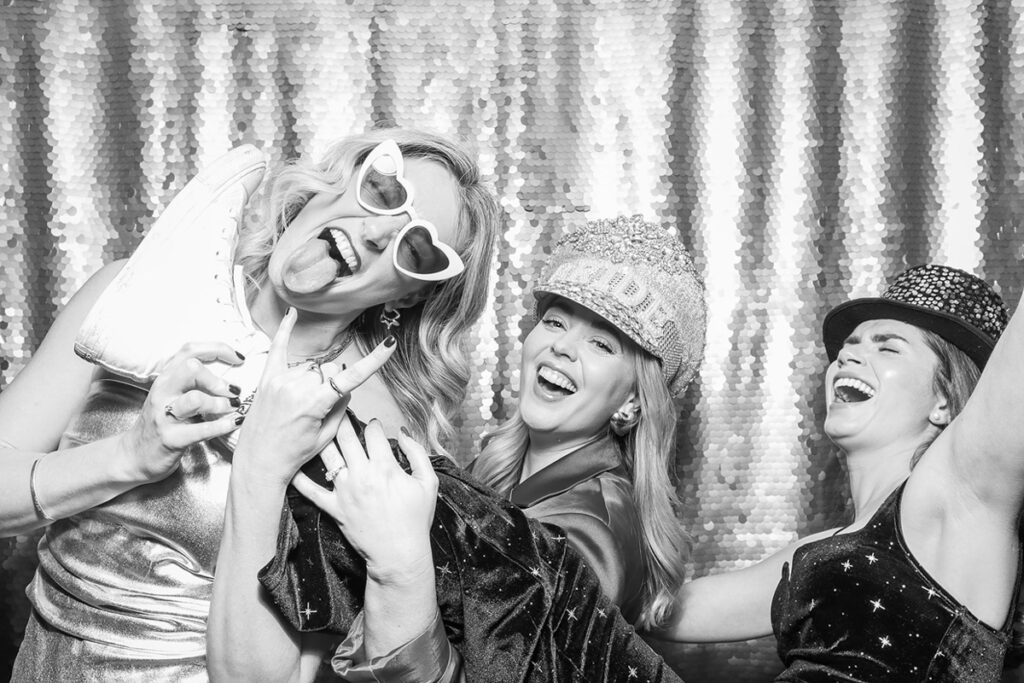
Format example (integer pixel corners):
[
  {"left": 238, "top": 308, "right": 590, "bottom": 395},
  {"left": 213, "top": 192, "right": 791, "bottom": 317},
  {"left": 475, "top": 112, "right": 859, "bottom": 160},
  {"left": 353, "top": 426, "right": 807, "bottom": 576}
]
[{"left": 534, "top": 215, "right": 707, "bottom": 397}]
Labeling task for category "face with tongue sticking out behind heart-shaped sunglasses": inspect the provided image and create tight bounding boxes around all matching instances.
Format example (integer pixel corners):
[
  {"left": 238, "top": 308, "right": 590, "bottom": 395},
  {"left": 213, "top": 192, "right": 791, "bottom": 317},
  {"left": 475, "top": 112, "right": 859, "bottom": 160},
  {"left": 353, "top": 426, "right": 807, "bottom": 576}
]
[{"left": 267, "top": 158, "right": 460, "bottom": 314}]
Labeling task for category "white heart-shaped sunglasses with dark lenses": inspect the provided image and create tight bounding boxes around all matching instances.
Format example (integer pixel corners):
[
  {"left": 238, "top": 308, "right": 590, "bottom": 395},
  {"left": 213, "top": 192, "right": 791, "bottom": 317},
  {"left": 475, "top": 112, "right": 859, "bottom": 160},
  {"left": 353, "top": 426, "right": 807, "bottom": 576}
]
[{"left": 355, "top": 140, "right": 466, "bottom": 282}]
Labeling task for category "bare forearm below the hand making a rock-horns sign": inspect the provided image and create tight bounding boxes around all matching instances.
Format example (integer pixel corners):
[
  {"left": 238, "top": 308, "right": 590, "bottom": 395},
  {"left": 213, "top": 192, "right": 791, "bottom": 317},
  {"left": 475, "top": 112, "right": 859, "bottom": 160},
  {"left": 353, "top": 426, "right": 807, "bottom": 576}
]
[{"left": 207, "top": 466, "right": 302, "bottom": 681}]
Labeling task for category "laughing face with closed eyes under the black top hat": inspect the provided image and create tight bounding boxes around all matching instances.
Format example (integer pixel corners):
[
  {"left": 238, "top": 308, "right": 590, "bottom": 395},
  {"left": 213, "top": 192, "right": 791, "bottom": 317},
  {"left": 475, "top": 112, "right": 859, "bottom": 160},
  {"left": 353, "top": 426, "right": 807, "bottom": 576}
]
[{"left": 824, "top": 319, "right": 948, "bottom": 453}]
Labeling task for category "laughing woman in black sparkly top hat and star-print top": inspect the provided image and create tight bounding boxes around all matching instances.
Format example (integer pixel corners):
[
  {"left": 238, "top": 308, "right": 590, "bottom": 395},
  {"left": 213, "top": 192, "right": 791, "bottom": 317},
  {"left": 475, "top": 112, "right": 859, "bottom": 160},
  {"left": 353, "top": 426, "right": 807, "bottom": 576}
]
[{"left": 663, "top": 265, "right": 1024, "bottom": 683}]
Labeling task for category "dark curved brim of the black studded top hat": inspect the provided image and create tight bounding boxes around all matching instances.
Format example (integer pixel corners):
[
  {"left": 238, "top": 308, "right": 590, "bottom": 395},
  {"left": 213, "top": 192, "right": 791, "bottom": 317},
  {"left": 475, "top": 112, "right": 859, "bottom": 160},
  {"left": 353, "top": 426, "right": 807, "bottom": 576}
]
[{"left": 821, "top": 298, "right": 995, "bottom": 370}]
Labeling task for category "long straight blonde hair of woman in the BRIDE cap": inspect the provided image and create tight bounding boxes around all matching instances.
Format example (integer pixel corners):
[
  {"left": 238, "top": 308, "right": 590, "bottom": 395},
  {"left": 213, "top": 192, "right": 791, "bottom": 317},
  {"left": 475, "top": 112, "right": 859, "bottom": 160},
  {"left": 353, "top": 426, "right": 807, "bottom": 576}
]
[{"left": 473, "top": 323, "right": 690, "bottom": 629}]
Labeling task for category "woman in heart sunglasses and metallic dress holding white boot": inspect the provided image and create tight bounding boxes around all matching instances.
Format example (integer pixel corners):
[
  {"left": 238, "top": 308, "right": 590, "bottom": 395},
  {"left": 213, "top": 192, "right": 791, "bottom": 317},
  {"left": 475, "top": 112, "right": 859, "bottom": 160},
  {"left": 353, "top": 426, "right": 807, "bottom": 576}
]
[{"left": 0, "top": 129, "right": 497, "bottom": 682}]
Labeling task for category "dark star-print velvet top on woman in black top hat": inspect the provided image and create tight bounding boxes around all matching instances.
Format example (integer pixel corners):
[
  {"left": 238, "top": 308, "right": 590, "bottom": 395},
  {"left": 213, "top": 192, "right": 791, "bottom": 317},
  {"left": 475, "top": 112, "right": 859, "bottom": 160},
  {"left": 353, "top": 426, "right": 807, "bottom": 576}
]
[{"left": 772, "top": 484, "right": 1010, "bottom": 683}]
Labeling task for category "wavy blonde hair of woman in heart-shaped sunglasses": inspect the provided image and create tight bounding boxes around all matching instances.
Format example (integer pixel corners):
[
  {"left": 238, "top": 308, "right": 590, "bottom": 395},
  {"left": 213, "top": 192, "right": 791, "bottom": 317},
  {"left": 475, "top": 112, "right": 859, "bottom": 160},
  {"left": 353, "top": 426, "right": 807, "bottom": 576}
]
[{"left": 236, "top": 128, "right": 499, "bottom": 455}]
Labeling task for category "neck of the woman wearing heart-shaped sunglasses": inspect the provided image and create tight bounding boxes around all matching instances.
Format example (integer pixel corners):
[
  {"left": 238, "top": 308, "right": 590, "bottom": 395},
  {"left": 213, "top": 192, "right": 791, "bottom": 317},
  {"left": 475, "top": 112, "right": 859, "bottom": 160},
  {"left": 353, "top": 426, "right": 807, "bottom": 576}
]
[{"left": 249, "top": 285, "right": 359, "bottom": 360}]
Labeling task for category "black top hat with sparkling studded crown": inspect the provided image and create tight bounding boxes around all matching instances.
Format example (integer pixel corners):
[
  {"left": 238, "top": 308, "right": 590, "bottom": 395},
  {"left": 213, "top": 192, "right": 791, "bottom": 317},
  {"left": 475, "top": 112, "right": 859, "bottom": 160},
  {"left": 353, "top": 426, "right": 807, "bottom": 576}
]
[{"left": 822, "top": 264, "right": 1009, "bottom": 369}]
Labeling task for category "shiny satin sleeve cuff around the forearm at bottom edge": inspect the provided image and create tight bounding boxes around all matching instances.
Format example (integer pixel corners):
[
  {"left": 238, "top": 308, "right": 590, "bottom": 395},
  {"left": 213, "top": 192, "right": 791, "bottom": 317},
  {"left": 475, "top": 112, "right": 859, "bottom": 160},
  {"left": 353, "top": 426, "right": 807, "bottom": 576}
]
[{"left": 331, "top": 611, "right": 466, "bottom": 683}]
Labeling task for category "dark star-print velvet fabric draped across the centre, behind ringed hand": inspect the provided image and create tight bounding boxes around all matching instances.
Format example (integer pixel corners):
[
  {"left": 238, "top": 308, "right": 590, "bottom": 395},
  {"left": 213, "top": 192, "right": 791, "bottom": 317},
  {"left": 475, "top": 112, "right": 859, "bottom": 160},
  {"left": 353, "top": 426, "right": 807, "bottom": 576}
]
[{"left": 259, "top": 414, "right": 680, "bottom": 683}]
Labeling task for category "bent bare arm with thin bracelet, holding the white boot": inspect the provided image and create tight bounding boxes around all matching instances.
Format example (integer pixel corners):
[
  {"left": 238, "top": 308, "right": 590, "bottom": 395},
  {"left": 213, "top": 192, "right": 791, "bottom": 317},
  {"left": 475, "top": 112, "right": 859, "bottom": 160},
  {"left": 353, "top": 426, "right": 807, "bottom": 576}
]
[{"left": 0, "top": 262, "right": 239, "bottom": 536}]
